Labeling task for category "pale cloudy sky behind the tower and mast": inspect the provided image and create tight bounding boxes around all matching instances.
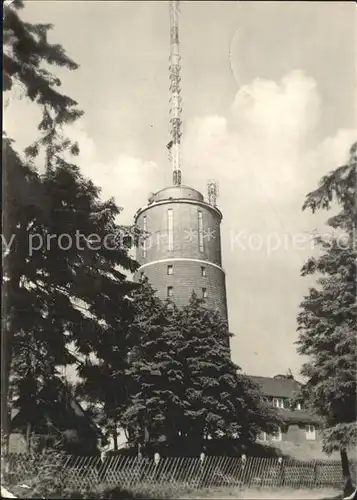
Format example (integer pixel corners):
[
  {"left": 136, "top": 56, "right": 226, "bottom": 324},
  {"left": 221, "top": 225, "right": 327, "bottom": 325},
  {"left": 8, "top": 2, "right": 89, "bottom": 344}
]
[{"left": 4, "top": 0, "right": 357, "bottom": 376}]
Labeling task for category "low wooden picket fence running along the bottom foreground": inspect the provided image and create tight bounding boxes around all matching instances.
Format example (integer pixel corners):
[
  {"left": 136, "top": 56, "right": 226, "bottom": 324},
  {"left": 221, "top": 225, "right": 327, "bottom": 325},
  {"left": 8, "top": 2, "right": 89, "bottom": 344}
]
[{"left": 2, "top": 455, "right": 356, "bottom": 489}]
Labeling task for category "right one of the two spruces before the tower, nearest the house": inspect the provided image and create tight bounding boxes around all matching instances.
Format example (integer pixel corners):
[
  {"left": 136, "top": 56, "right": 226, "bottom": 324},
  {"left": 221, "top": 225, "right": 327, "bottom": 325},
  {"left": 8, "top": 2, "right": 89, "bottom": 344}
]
[{"left": 179, "top": 294, "right": 277, "bottom": 446}]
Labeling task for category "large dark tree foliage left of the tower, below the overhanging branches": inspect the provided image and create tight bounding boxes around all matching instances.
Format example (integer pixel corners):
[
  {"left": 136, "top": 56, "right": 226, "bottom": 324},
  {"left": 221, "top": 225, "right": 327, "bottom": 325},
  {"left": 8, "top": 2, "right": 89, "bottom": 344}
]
[{"left": 5, "top": 134, "right": 136, "bottom": 446}]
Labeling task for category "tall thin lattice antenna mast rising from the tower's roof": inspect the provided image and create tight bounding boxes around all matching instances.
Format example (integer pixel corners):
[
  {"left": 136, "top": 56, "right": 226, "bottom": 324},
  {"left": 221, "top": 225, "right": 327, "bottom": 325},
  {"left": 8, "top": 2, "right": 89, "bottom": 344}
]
[{"left": 169, "top": 0, "right": 182, "bottom": 186}]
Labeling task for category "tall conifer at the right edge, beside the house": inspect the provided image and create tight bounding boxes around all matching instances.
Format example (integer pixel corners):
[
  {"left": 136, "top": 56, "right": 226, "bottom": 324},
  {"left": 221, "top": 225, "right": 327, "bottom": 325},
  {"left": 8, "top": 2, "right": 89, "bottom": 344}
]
[{"left": 297, "top": 143, "right": 357, "bottom": 491}]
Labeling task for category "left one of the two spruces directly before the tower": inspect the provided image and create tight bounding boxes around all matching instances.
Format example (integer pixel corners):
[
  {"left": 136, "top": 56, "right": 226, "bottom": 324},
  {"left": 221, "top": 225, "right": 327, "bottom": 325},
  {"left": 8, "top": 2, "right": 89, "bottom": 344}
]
[{"left": 123, "top": 279, "right": 185, "bottom": 452}]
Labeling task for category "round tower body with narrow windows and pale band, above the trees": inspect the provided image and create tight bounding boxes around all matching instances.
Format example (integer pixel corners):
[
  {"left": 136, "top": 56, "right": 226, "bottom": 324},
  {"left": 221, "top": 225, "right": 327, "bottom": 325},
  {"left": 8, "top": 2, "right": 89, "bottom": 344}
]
[{"left": 135, "top": 186, "right": 227, "bottom": 319}]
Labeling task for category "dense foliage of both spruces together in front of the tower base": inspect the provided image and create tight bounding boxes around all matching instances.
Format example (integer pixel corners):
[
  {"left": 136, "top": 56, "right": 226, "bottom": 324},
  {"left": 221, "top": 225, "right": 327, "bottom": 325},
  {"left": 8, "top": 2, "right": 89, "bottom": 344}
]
[{"left": 124, "top": 281, "right": 277, "bottom": 453}]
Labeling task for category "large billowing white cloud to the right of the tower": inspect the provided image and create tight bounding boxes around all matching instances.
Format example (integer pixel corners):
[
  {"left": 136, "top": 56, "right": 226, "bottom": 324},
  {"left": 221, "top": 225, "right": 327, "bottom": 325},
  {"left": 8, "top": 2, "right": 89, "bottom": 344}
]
[{"left": 183, "top": 70, "right": 356, "bottom": 236}]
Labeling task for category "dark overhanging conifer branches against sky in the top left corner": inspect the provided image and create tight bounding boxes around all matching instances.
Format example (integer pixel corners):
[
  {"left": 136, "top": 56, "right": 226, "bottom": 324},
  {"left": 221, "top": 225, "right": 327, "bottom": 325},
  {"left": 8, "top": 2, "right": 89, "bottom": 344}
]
[{"left": 3, "top": 0, "right": 83, "bottom": 164}]
